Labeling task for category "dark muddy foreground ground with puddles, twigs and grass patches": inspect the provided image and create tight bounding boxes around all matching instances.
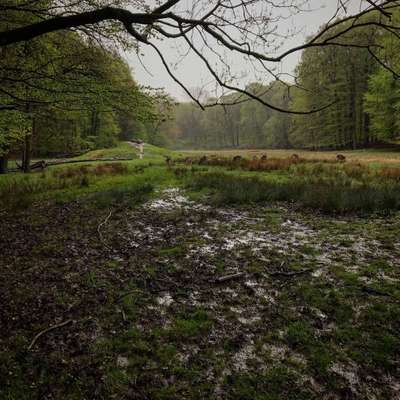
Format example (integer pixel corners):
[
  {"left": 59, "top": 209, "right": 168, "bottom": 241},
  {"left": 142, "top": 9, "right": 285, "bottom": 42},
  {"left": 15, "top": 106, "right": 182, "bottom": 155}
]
[{"left": 0, "top": 188, "right": 400, "bottom": 400}]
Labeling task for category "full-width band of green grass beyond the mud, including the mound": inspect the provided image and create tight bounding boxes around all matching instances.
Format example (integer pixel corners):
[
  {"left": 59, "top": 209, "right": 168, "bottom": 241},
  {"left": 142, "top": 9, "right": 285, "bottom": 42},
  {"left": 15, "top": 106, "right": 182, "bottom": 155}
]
[{"left": 0, "top": 142, "right": 400, "bottom": 213}]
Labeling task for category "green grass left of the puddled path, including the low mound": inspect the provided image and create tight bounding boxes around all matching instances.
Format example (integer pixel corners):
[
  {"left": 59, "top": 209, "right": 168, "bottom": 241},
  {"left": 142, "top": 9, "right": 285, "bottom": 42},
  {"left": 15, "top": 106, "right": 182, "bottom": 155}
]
[{"left": 0, "top": 143, "right": 178, "bottom": 209}]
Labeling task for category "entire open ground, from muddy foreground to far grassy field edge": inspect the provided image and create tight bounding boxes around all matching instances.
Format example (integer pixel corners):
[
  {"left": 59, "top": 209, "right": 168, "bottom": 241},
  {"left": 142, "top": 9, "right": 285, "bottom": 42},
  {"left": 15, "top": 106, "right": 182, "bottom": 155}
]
[{"left": 0, "top": 143, "right": 400, "bottom": 400}]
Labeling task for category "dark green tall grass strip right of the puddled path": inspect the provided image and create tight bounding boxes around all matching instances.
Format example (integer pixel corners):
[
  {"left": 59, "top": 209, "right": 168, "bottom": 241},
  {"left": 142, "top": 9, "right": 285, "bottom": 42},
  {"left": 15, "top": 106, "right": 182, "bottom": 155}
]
[{"left": 187, "top": 172, "right": 400, "bottom": 213}]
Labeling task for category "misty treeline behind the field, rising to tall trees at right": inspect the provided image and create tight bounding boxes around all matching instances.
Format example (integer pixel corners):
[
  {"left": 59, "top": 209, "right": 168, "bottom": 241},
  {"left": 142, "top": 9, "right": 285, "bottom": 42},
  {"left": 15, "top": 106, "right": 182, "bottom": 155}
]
[{"left": 171, "top": 14, "right": 400, "bottom": 149}]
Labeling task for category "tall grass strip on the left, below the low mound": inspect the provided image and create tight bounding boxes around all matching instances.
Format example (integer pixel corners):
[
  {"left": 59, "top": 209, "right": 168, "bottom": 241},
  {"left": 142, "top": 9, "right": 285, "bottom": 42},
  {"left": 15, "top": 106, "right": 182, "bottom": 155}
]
[{"left": 0, "top": 163, "right": 159, "bottom": 209}]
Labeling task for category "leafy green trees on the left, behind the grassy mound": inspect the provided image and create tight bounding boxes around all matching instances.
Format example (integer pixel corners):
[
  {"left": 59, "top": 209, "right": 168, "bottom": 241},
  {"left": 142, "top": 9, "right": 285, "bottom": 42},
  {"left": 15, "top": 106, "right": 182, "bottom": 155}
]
[{"left": 0, "top": 1, "right": 169, "bottom": 172}]
